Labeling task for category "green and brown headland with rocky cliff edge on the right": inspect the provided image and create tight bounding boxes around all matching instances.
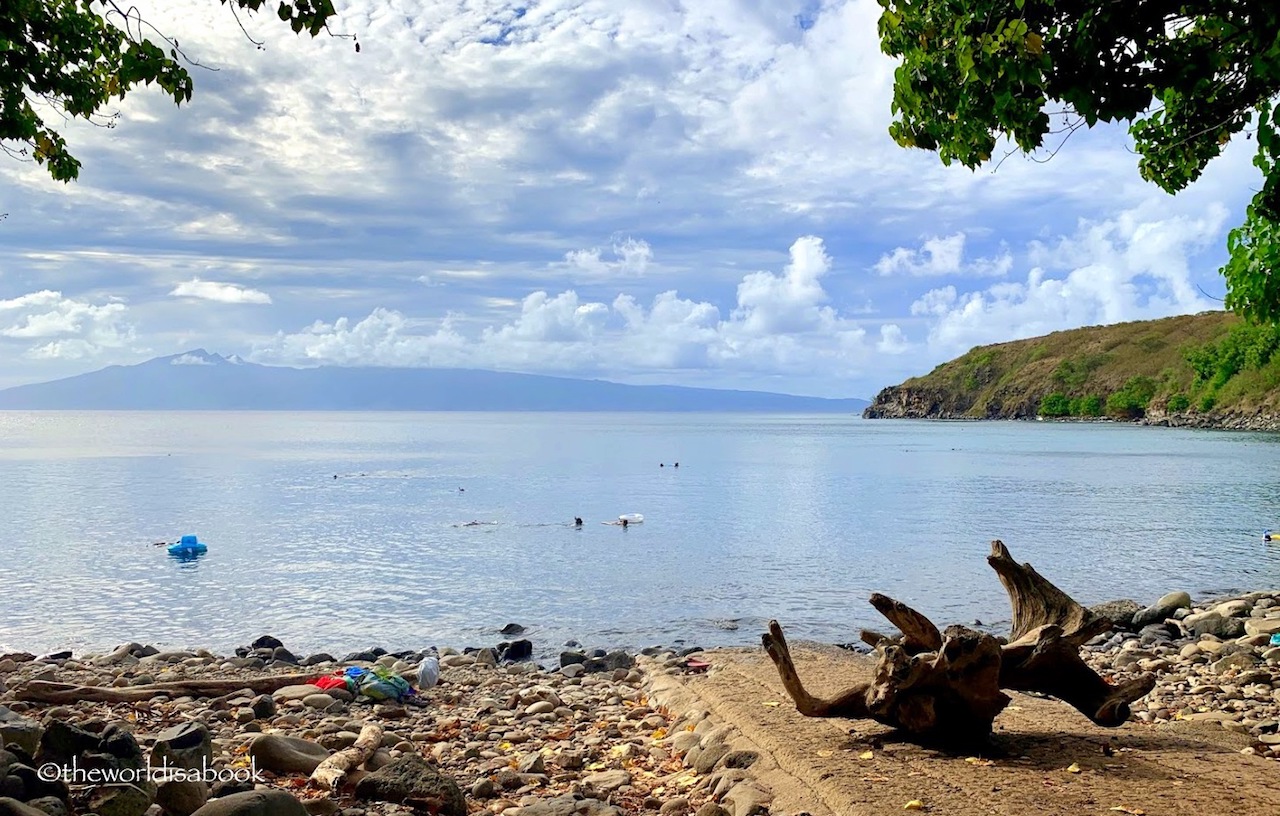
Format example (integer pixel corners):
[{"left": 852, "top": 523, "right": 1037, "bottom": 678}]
[{"left": 863, "top": 312, "right": 1280, "bottom": 430}]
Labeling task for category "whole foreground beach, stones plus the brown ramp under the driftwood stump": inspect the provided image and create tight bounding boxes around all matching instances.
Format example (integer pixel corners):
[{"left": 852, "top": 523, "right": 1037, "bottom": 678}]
[{"left": 0, "top": 592, "right": 1280, "bottom": 816}]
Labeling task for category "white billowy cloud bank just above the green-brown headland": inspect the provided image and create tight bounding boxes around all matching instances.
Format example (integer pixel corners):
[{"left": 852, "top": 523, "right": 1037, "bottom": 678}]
[{"left": 911, "top": 206, "right": 1226, "bottom": 354}]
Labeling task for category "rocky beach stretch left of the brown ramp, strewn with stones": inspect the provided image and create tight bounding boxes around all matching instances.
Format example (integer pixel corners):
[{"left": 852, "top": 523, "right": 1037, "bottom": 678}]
[{"left": 0, "top": 637, "right": 768, "bottom": 816}]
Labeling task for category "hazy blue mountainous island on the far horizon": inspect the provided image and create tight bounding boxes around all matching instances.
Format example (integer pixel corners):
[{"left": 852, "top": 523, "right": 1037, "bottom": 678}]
[{"left": 0, "top": 349, "right": 869, "bottom": 413}]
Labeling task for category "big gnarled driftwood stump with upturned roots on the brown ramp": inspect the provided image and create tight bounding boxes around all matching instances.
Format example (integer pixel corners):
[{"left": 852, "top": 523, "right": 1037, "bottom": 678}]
[{"left": 762, "top": 540, "right": 1156, "bottom": 743}]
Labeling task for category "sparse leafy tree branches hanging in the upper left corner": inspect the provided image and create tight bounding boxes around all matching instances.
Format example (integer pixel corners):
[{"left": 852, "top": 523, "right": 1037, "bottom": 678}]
[{"left": 0, "top": 0, "right": 343, "bottom": 182}]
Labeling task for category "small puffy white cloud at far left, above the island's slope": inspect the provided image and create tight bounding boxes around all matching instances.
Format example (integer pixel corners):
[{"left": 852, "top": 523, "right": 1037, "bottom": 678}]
[{"left": 0, "top": 289, "right": 134, "bottom": 359}]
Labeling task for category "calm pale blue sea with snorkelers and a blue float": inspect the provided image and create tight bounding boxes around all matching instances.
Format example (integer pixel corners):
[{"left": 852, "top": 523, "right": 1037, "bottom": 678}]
[{"left": 0, "top": 412, "right": 1280, "bottom": 656}]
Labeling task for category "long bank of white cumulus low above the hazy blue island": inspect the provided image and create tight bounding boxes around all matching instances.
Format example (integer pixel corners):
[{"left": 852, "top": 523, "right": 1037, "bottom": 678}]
[{"left": 255, "top": 235, "right": 880, "bottom": 383}]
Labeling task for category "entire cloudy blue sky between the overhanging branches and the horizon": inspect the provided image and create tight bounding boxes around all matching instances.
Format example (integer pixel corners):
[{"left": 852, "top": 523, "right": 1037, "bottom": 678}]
[{"left": 0, "top": 0, "right": 1260, "bottom": 398}]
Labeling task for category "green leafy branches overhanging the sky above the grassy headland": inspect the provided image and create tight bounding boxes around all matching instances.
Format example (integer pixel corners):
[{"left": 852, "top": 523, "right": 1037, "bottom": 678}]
[{"left": 879, "top": 0, "right": 1280, "bottom": 322}]
